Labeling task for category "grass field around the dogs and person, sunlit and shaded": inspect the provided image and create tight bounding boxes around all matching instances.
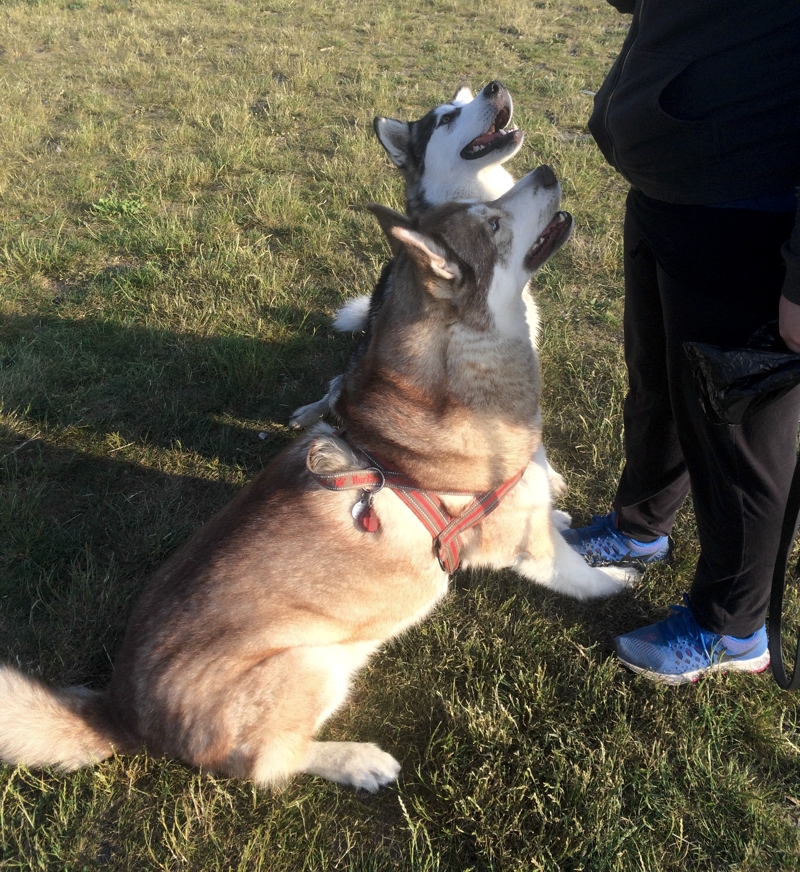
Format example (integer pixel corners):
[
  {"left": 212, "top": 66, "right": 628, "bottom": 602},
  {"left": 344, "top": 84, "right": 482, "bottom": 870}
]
[{"left": 0, "top": 0, "right": 800, "bottom": 872}]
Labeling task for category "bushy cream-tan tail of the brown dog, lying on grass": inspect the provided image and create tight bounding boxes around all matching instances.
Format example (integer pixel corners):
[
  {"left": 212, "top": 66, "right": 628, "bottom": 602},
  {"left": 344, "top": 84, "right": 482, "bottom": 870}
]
[{"left": 0, "top": 666, "right": 121, "bottom": 771}]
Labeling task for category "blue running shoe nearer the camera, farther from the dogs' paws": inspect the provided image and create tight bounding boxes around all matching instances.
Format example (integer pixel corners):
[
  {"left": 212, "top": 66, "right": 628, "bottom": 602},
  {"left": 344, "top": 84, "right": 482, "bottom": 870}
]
[{"left": 614, "top": 594, "right": 769, "bottom": 684}]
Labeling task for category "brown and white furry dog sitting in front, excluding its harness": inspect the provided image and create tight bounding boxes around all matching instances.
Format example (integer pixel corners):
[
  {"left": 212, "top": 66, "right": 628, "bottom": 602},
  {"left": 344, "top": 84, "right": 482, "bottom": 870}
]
[{"left": 0, "top": 167, "right": 632, "bottom": 790}]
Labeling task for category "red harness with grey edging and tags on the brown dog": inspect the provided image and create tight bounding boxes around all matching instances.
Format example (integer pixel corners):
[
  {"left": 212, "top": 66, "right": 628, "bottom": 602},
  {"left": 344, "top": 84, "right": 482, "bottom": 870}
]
[{"left": 306, "top": 434, "right": 525, "bottom": 574}]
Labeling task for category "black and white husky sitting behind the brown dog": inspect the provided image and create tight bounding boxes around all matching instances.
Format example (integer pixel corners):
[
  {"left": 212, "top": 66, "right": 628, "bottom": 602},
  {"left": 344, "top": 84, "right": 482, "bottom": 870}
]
[{"left": 289, "top": 81, "right": 538, "bottom": 430}]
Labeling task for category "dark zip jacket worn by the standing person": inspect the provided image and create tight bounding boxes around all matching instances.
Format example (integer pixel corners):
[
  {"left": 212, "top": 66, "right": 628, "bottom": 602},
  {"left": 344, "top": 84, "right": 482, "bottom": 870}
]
[{"left": 589, "top": 0, "right": 800, "bottom": 302}]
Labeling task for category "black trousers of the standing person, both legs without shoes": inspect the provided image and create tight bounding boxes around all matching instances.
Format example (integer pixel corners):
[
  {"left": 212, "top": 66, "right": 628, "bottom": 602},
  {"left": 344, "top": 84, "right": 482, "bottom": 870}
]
[{"left": 614, "top": 191, "right": 800, "bottom": 636}]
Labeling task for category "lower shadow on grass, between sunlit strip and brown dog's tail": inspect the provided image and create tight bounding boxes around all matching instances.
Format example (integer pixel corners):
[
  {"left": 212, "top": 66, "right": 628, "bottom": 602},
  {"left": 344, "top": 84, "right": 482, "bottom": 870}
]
[{"left": 0, "top": 427, "right": 238, "bottom": 684}]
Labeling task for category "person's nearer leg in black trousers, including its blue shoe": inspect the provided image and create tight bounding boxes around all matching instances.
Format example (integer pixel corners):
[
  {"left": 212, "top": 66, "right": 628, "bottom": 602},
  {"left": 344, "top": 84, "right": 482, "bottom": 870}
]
[{"left": 616, "top": 207, "right": 800, "bottom": 683}]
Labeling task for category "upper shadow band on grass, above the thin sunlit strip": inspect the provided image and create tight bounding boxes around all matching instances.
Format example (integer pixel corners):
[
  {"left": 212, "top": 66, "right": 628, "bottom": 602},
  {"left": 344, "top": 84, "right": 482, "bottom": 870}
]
[{"left": 0, "top": 307, "right": 352, "bottom": 474}]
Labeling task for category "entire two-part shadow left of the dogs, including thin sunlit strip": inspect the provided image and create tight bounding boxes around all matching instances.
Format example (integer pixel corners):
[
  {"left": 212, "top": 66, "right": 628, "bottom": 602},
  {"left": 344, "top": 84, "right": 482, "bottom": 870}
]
[{"left": 0, "top": 311, "right": 351, "bottom": 686}]
